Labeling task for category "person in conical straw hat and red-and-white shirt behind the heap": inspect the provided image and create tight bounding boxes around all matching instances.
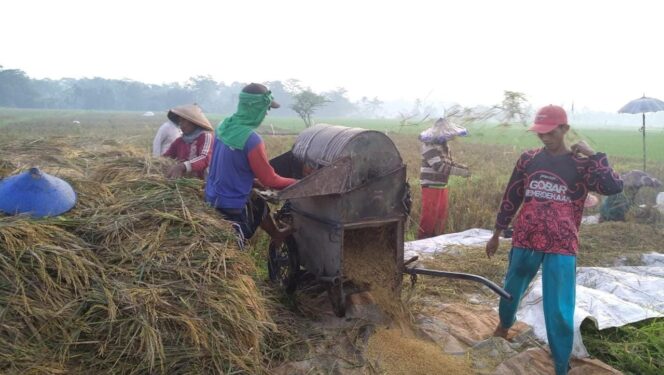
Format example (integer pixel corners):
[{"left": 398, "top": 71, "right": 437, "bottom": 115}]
[{"left": 163, "top": 104, "right": 214, "bottom": 179}]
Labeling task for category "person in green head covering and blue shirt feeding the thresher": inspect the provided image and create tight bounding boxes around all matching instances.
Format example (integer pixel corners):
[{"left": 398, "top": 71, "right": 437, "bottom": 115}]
[{"left": 205, "top": 83, "right": 296, "bottom": 245}]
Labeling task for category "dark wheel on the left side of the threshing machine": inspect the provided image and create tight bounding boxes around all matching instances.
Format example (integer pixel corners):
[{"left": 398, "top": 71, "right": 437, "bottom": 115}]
[{"left": 267, "top": 236, "right": 300, "bottom": 294}]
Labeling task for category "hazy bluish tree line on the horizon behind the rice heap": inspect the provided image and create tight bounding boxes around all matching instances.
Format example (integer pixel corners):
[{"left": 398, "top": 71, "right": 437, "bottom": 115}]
[{"left": 0, "top": 65, "right": 383, "bottom": 118}]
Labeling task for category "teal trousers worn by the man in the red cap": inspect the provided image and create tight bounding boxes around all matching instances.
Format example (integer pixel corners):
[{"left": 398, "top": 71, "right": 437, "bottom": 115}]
[{"left": 498, "top": 247, "right": 576, "bottom": 375}]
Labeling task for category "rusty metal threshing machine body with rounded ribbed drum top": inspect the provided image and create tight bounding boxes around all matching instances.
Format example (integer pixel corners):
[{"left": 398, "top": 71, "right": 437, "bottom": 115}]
[{"left": 280, "top": 124, "right": 409, "bottom": 314}]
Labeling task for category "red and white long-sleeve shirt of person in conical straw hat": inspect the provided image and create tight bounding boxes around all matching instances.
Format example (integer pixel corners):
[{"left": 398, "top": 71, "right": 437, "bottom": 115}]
[{"left": 163, "top": 131, "right": 214, "bottom": 179}]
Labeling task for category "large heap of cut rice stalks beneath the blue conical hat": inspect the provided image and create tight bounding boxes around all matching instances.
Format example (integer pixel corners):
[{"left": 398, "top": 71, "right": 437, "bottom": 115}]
[{"left": 0, "top": 141, "right": 278, "bottom": 374}]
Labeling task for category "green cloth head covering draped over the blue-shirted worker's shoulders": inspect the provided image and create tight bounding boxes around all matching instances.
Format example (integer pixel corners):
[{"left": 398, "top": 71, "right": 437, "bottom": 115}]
[{"left": 217, "top": 91, "right": 272, "bottom": 150}]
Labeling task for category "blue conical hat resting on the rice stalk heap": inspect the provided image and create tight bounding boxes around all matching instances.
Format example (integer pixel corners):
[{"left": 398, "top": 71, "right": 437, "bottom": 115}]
[{"left": 0, "top": 168, "right": 76, "bottom": 217}]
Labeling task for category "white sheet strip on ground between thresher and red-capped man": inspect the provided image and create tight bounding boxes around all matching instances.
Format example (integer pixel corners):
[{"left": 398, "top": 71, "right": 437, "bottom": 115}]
[{"left": 404, "top": 228, "right": 493, "bottom": 259}]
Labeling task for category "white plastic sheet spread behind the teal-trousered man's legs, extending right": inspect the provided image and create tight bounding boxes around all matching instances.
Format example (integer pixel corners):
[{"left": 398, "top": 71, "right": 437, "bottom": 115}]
[{"left": 517, "top": 253, "right": 664, "bottom": 357}]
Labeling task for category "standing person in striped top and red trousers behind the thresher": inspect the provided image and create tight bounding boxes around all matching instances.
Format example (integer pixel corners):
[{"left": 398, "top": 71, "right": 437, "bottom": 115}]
[{"left": 418, "top": 118, "right": 470, "bottom": 238}]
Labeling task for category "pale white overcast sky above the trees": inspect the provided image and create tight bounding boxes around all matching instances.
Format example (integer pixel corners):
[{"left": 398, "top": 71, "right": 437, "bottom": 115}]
[{"left": 0, "top": 0, "right": 664, "bottom": 112}]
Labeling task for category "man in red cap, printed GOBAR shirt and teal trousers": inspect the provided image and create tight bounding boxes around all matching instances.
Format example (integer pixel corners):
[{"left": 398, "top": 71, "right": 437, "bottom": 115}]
[{"left": 486, "top": 105, "right": 623, "bottom": 375}]
